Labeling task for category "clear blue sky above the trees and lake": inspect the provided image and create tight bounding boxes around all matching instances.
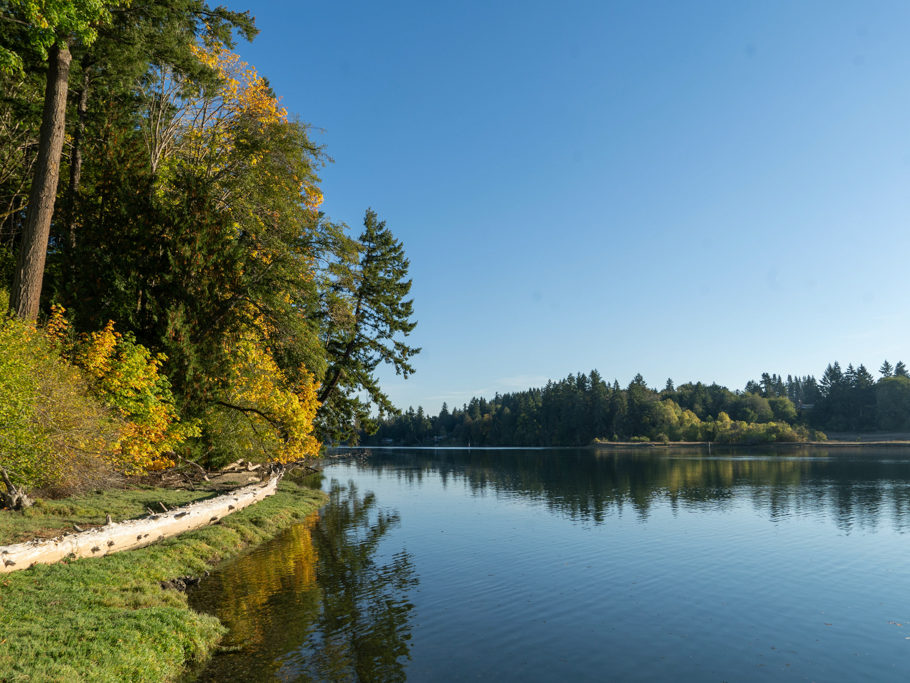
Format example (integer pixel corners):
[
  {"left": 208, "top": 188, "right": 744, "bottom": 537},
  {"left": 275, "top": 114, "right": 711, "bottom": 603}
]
[{"left": 221, "top": 0, "right": 910, "bottom": 413}]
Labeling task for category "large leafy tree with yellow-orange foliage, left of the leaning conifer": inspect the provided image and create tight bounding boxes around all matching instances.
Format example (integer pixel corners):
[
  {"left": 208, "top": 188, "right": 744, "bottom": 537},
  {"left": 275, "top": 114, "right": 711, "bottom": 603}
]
[{"left": 60, "top": 37, "right": 326, "bottom": 463}]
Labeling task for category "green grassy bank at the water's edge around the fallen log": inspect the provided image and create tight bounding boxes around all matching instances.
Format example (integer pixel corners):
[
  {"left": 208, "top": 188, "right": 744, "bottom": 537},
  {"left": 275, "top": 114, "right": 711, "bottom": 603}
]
[{"left": 0, "top": 481, "right": 324, "bottom": 683}]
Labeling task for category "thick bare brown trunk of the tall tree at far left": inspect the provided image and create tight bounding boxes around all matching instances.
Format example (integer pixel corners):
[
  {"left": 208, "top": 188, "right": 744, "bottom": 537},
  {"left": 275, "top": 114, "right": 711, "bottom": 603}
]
[{"left": 10, "top": 44, "right": 72, "bottom": 321}]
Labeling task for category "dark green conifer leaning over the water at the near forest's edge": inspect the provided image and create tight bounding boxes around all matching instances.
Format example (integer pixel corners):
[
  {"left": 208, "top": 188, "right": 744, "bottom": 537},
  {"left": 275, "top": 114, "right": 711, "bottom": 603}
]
[{"left": 318, "top": 209, "right": 420, "bottom": 440}]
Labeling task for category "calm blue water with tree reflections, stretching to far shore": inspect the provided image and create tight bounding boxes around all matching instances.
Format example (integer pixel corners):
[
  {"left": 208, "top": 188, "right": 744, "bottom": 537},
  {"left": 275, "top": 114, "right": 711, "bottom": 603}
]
[{"left": 191, "top": 449, "right": 910, "bottom": 681}]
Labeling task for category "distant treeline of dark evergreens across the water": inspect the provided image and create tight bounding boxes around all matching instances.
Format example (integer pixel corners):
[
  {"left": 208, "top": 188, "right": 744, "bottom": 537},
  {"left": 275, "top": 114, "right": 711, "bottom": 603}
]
[{"left": 365, "top": 361, "right": 910, "bottom": 446}]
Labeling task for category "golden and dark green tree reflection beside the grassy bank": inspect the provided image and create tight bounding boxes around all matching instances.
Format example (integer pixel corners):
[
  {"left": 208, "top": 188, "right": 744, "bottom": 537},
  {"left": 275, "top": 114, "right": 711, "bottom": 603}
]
[{"left": 190, "top": 481, "right": 417, "bottom": 681}]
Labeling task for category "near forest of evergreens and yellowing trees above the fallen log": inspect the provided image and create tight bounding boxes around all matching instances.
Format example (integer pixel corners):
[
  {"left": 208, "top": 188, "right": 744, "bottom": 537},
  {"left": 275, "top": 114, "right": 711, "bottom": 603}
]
[{"left": 0, "top": 0, "right": 419, "bottom": 503}]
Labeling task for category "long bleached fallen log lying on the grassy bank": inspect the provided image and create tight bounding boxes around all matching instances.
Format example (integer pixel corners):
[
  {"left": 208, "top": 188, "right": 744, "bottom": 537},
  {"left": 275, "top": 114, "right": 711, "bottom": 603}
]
[{"left": 0, "top": 472, "right": 283, "bottom": 574}]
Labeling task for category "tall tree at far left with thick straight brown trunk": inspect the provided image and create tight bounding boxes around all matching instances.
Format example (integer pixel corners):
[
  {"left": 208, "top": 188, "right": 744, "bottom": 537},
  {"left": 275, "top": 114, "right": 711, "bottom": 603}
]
[{"left": 0, "top": 0, "right": 255, "bottom": 320}]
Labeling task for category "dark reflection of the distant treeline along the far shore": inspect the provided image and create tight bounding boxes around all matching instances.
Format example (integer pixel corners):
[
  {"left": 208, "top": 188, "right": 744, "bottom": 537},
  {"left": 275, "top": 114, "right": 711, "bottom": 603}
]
[{"left": 352, "top": 449, "right": 910, "bottom": 531}]
